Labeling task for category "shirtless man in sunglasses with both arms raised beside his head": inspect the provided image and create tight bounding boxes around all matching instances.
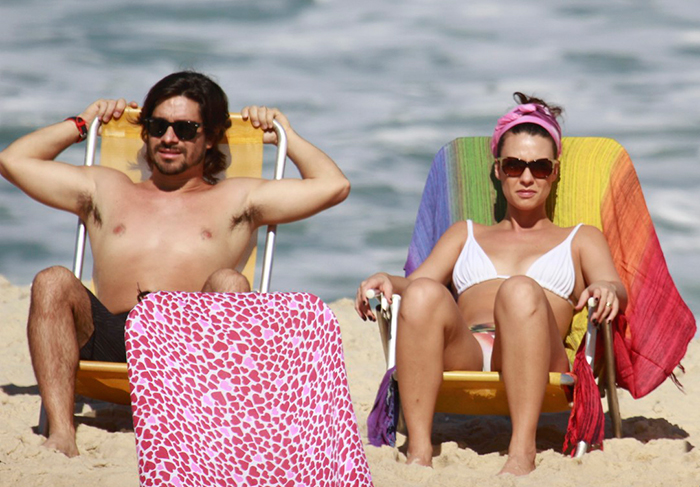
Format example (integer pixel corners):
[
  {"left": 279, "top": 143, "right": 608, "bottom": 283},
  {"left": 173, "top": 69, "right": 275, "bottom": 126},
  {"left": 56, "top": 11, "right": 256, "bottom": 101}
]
[{"left": 0, "top": 72, "right": 350, "bottom": 456}]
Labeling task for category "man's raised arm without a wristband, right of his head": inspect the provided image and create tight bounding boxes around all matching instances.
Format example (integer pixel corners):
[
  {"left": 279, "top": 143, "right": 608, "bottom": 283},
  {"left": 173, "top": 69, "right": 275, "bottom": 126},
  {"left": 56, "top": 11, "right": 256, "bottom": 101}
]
[{"left": 241, "top": 106, "right": 350, "bottom": 225}]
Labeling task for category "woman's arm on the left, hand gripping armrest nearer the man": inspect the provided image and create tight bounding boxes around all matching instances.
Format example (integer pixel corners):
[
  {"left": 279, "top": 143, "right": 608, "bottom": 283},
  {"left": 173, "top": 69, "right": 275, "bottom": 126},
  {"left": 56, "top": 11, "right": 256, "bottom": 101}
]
[{"left": 355, "top": 222, "right": 467, "bottom": 321}]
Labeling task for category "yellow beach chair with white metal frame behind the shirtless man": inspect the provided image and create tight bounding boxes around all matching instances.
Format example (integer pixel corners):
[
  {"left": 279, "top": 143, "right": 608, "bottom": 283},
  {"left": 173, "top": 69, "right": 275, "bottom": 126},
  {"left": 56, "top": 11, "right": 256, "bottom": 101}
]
[{"left": 38, "top": 108, "right": 287, "bottom": 435}]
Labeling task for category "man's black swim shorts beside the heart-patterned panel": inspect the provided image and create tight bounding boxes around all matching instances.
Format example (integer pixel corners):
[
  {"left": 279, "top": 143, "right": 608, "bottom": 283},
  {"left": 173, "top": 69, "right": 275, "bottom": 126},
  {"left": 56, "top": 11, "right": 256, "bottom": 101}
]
[{"left": 80, "top": 288, "right": 129, "bottom": 362}]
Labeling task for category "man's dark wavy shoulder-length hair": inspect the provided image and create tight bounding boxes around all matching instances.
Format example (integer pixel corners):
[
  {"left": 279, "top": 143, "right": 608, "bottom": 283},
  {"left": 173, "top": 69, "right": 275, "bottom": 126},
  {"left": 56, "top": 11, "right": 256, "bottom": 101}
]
[{"left": 137, "top": 71, "right": 231, "bottom": 184}]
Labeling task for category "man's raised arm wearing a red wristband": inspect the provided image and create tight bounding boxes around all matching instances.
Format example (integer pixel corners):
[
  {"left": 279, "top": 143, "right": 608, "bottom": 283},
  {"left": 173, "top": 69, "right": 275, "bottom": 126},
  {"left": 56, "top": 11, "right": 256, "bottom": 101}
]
[{"left": 0, "top": 99, "right": 131, "bottom": 213}]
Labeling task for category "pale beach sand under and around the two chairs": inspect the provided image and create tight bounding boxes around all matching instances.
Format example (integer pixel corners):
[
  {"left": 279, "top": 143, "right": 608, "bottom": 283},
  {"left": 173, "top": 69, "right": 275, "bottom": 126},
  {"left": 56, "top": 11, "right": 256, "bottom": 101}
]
[{"left": 0, "top": 277, "right": 700, "bottom": 487}]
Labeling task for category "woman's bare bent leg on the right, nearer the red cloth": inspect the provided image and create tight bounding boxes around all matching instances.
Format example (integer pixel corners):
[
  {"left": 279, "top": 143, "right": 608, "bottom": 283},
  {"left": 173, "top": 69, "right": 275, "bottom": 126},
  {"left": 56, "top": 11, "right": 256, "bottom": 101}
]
[{"left": 492, "top": 276, "right": 569, "bottom": 475}]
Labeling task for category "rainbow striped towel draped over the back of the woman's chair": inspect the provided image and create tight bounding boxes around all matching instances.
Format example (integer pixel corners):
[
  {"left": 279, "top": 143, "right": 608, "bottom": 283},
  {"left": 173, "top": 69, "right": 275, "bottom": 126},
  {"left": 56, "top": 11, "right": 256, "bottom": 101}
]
[{"left": 404, "top": 137, "right": 696, "bottom": 450}]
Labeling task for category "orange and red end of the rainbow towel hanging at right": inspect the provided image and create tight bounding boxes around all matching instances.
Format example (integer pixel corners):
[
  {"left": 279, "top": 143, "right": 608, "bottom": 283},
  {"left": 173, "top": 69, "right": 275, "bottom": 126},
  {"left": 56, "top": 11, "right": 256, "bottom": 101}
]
[{"left": 602, "top": 154, "right": 696, "bottom": 398}]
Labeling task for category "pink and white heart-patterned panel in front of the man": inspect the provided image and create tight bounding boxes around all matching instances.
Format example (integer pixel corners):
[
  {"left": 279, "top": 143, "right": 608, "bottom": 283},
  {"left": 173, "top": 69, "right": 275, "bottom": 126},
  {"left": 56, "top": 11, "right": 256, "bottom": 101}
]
[{"left": 126, "top": 292, "right": 372, "bottom": 487}]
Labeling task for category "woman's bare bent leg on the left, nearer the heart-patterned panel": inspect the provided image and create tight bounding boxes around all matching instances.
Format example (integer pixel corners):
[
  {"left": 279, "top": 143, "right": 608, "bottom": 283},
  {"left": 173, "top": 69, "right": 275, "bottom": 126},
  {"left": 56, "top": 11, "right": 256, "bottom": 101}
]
[{"left": 396, "top": 279, "right": 483, "bottom": 466}]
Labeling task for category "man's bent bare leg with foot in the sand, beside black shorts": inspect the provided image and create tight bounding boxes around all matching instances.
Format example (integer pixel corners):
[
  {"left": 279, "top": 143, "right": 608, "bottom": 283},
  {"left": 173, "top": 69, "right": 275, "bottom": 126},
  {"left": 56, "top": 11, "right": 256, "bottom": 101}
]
[{"left": 27, "top": 267, "right": 94, "bottom": 457}]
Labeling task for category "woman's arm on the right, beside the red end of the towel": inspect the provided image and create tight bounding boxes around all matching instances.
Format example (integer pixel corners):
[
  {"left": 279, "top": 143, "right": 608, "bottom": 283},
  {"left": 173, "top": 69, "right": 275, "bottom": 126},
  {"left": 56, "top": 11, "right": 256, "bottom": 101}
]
[{"left": 576, "top": 225, "right": 627, "bottom": 323}]
